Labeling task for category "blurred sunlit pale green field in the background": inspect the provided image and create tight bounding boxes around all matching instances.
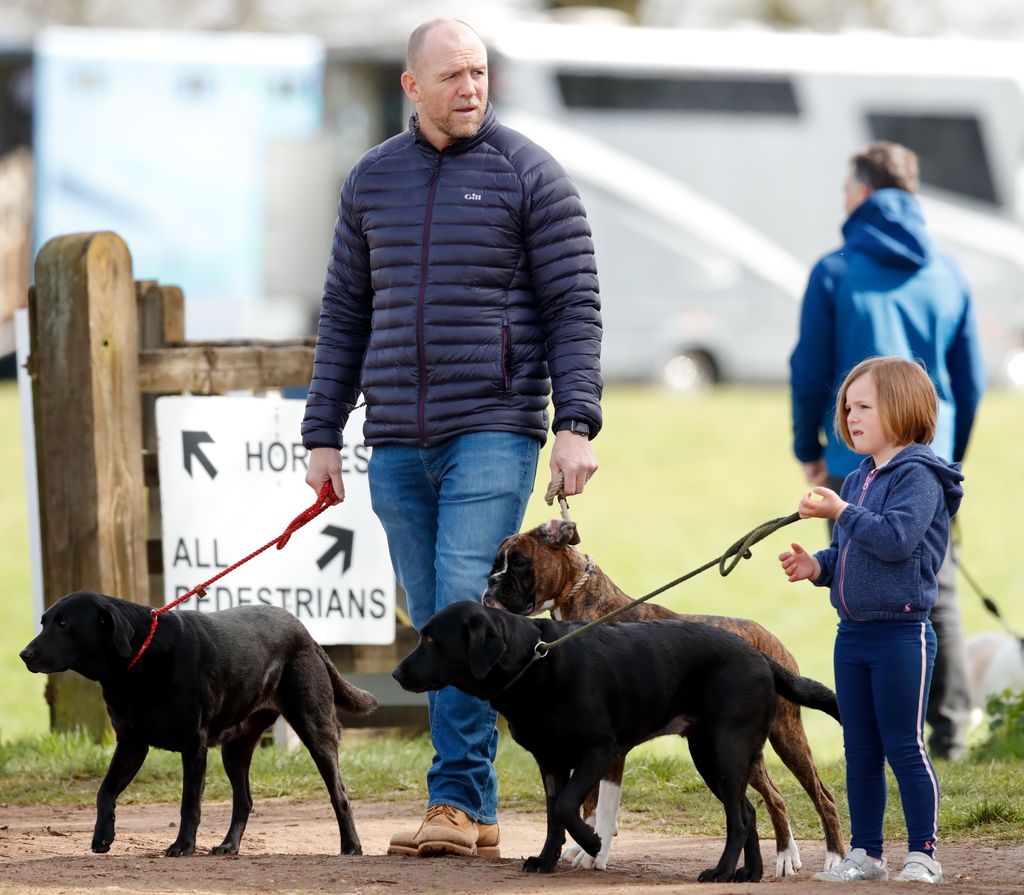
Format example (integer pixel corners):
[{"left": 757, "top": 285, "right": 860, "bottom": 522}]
[{"left": 0, "top": 382, "right": 1024, "bottom": 760}]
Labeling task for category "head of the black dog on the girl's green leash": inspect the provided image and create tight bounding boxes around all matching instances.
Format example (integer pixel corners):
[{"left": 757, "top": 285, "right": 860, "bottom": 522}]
[{"left": 392, "top": 600, "right": 537, "bottom": 699}]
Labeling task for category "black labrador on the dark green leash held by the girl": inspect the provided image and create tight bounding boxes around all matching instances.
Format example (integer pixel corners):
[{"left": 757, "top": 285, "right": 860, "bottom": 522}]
[{"left": 393, "top": 601, "right": 839, "bottom": 883}]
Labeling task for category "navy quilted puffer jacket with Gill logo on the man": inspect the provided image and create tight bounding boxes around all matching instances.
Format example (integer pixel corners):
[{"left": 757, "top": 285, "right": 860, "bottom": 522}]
[{"left": 302, "top": 105, "right": 602, "bottom": 448}]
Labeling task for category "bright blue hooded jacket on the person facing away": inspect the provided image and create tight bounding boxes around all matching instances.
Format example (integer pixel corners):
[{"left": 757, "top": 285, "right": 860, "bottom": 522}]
[{"left": 790, "top": 189, "right": 985, "bottom": 477}]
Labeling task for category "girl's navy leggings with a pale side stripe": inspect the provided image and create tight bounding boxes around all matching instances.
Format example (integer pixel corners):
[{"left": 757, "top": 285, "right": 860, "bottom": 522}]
[{"left": 835, "top": 619, "right": 939, "bottom": 858}]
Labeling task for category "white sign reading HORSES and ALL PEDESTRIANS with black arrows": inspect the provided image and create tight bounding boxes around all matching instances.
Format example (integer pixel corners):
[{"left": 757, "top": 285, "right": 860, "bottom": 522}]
[{"left": 157, "top": 397, "right": 395, "bottom": 644}]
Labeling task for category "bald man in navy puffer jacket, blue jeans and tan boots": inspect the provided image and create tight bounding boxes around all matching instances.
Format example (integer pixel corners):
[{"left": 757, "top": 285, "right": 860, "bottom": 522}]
[{"left": 302, "top": 19, "right": 602, "bottom": 857}]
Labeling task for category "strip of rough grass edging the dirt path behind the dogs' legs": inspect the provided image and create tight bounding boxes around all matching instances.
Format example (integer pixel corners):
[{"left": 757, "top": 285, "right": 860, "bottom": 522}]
[{"left": 0, "top": 720, "right": 1024, "bottom": 842}]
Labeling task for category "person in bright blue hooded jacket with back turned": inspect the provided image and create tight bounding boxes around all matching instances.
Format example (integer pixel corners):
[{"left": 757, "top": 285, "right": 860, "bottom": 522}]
[{"left": 790, "top": 142, "right": 985, "bottom": 759}]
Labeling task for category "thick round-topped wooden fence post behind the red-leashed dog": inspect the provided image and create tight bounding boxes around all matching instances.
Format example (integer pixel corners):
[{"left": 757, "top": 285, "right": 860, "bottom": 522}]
[{"left": 29, "top": 232, "right": 148, "bottom": 738}]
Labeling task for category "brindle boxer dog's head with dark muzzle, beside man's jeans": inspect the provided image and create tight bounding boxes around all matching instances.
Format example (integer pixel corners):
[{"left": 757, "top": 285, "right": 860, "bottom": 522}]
[{"left": 483, "top": 519, "right": 580, "bottom": 615}]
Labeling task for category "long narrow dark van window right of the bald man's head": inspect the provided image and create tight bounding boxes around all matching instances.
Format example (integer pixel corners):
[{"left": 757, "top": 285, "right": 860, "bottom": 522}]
[{"left": 557, "top": 71, "right": 800, "bottom": 116}]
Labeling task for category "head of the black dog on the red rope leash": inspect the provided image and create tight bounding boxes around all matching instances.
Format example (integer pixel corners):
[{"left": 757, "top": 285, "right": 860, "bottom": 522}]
[{"left": 20, "top": 591, "right": 134, "bottom": 680}]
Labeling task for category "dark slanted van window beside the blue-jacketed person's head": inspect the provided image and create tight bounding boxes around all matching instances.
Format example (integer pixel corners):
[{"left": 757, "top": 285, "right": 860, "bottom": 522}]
[{"left": 867, "top": 111, "right": 1000, "bottom": 205}]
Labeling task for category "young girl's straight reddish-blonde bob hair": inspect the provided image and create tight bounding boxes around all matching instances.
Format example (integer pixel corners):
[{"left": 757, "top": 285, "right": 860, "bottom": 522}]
[{"left": 835, "top": 357, "right": 938, "bottom": 451}]
